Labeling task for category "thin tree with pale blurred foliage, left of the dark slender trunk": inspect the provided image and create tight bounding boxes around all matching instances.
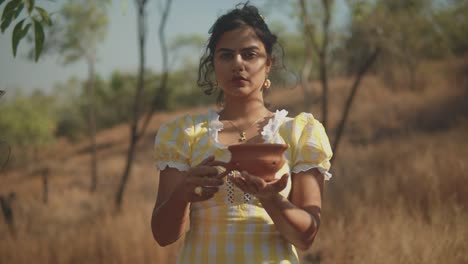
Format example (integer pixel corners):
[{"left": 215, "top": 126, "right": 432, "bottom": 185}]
[{"left": 44, "top": 0, "right": 111, "bottom": 192}]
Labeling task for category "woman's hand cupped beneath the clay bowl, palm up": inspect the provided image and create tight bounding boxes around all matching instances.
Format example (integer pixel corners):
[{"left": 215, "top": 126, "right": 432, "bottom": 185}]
[{"left": 228, "top": 171, "right": 289, "bottom": 198}]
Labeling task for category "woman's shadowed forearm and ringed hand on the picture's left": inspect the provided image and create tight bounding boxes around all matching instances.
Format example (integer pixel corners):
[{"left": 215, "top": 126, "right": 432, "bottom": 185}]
[{"left": 151, "top": 157, "right": 223, "bottom": 246}]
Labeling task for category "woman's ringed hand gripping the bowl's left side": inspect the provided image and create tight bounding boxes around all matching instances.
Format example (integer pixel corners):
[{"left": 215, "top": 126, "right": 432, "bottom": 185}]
[{"left": 175, "top": 156, "right": 224, "bottom": 202}]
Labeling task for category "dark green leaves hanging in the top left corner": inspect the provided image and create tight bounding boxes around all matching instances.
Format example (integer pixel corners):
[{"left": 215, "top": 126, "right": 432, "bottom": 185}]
[{"left": 0, "top": 0, "right": 52, "bottom": 61}]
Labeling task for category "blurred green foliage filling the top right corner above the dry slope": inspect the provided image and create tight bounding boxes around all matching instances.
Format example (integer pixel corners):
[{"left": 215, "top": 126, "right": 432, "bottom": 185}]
[{"left": 338, "top": 0, "right": 468, "bottom": 88}]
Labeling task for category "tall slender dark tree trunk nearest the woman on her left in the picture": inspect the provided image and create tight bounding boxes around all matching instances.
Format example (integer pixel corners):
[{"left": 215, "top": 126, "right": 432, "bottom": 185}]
[{"left": 115, "top": 0, "right": 147, "bottom": 208}]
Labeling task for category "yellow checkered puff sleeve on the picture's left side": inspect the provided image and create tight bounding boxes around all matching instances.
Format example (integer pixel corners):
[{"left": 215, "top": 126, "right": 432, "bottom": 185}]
[{"left": 154, "top": 116, "right": 192, "bottom": 171}]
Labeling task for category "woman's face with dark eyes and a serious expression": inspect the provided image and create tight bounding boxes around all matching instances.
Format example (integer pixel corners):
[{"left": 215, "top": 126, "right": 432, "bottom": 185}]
[{"left": 214, "top": 26, "right": 271, "bottom": 100}]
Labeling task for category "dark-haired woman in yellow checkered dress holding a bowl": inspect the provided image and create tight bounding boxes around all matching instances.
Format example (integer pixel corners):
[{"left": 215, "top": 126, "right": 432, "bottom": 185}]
[{"left": 151, "top": 4, "right": 332, "bottom": 263}]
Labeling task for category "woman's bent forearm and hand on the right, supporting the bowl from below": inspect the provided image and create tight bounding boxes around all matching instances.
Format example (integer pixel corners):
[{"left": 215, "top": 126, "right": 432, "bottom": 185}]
[{"left": 234, "top": 169, "right": 324, "bottom": 250}]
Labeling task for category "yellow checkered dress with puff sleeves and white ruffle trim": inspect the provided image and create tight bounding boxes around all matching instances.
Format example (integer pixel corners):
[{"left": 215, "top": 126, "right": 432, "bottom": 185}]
[{"left": 155, "top": 110, "right": 332, "bottom": 264}]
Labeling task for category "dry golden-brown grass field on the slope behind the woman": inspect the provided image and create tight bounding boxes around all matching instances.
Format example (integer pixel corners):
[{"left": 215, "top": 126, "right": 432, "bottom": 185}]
[{"left": 0, "top": 58, "right": 468, "bottom": 264}]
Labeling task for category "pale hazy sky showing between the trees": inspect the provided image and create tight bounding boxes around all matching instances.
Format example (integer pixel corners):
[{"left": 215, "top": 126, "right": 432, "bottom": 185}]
[{"left": 0, "top": 0, "right": 348, "bottom": 93}]
